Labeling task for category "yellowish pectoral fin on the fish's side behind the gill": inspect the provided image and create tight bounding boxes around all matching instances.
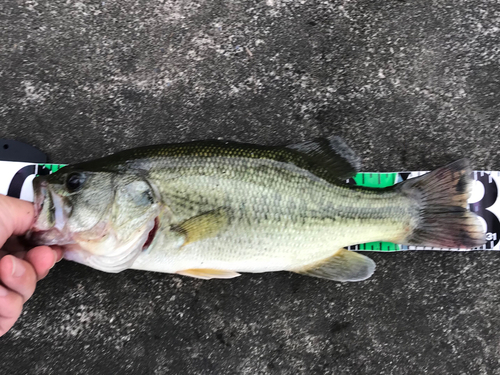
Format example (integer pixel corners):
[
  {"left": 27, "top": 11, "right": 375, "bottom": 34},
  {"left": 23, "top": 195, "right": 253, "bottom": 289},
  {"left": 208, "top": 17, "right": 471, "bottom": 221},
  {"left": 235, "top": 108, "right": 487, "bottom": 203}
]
[{"left": 172, "top": 208, "right": 229, "bottom": 246}]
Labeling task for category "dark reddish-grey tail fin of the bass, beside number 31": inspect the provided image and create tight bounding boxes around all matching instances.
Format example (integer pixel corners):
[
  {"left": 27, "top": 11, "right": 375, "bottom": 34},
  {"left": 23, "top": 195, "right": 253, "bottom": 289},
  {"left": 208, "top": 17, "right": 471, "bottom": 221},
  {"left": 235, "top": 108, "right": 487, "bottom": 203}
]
[{"left": 398, "top": 159, "right": 486, "bottom": 249}]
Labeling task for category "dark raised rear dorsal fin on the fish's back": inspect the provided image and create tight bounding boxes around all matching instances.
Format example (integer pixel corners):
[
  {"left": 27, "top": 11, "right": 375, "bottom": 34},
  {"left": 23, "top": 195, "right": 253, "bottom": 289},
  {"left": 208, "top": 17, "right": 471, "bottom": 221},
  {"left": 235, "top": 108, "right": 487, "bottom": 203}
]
[{"left": 286, "top": 137, "right": 360, "bottom": 181}]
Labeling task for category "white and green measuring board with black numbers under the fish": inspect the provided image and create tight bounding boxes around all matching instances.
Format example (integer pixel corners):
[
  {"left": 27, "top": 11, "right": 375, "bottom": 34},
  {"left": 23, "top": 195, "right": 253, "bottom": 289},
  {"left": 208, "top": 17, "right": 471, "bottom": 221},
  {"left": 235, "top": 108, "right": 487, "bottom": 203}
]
[{"left": 0, "top": 161, "right": 500, "bottom": 251}]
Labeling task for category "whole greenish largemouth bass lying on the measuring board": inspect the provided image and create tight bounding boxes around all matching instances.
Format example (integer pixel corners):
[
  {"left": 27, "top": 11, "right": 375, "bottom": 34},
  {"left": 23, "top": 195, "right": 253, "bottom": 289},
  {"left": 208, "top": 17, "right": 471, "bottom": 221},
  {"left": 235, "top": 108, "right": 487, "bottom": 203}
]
[{"left": 26, "top": 137, "right": 486, "bottom": 282}]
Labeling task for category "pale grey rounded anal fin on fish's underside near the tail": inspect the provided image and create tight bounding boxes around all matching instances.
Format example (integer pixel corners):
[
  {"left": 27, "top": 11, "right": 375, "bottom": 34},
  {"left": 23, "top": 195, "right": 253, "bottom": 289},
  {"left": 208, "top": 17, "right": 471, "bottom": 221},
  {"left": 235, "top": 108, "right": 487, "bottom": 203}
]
[{"left": 294, "top": 249, "right": 375, "bottom": 281}]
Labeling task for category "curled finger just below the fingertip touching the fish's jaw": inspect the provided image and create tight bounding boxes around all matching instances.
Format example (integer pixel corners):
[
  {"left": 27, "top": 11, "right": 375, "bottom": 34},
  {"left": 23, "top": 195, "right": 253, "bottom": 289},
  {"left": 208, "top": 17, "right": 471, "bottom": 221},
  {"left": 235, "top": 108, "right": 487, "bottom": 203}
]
[{"left": 0, "top": 255, "right": 38, "bottom": 302}]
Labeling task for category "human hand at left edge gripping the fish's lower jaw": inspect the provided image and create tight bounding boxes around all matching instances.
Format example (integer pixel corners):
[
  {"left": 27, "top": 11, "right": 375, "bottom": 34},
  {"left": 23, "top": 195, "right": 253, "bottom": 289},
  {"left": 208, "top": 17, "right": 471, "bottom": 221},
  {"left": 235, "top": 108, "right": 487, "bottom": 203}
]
[{"left": 0, "top": 195, "right": 63, "bottom": 336}]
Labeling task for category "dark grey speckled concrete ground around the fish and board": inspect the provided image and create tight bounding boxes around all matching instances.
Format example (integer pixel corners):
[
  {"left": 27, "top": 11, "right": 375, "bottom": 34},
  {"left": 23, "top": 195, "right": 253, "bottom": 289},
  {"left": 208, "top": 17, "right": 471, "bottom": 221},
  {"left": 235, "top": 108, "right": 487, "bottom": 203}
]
[{"left": 0, "top": 0, "right": 500, "bottom": 374}]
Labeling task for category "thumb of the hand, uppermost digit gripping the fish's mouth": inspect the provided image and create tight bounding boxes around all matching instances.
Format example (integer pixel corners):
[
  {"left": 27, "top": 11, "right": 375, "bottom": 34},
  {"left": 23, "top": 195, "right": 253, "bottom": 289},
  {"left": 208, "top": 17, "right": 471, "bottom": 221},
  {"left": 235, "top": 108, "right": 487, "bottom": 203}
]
[{"left": 0, "top": 195, "right": 35, "bottom": 244}]
